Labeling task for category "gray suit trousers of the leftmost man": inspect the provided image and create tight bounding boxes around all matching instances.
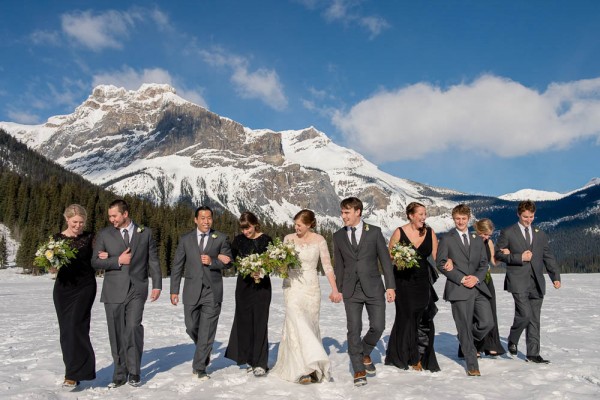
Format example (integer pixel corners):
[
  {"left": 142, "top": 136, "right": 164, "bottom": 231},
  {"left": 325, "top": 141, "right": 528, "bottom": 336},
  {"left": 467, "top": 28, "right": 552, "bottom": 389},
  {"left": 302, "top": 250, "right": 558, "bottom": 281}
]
[{"left": 104, "top": 285, "right": 146, "bottom": 381}]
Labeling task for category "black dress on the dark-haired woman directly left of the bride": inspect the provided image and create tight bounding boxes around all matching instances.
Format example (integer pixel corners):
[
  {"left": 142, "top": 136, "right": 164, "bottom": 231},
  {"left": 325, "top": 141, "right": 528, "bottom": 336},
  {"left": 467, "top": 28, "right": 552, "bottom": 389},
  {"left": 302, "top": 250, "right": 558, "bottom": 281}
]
[{"left": 225, "top": 234, "right": 272, "bottom": 371}]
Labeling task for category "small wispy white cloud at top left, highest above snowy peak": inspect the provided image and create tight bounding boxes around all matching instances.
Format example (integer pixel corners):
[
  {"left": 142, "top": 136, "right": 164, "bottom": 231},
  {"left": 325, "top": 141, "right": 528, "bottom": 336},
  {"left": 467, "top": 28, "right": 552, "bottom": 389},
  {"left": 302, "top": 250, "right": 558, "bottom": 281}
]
[{"left": 61, "top": 10, "right": 140, "bottom": 51}]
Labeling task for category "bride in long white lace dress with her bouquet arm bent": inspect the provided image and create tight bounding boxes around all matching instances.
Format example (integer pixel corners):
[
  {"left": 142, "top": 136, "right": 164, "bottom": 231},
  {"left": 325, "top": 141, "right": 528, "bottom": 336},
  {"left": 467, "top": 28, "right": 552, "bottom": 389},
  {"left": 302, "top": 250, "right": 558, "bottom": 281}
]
[{"left": 271, "top": 210, "right": 342, "bottom": 384}]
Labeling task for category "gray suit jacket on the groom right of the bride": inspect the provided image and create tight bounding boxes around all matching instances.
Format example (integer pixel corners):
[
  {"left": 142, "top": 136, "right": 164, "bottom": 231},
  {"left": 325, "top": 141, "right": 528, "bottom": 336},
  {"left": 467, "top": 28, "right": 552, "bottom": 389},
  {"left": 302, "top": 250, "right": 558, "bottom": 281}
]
[{"left": 333, "top": 223, "right": 396, "bottom": 298}]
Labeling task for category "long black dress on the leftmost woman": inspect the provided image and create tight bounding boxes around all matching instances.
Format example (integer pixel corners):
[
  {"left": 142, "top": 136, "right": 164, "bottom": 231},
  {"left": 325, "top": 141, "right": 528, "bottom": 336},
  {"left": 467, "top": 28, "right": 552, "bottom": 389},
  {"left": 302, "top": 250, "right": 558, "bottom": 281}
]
[{"left": 53, "top": 232, "right": 96, "bottom": 381}]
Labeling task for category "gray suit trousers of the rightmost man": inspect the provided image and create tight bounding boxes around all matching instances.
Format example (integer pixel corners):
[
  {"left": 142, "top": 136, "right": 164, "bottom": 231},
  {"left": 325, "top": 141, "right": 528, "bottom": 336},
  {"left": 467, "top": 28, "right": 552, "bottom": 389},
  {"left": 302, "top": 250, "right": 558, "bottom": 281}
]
[{"left": 508, "top": 290, "right": 544, "bottom": 356}]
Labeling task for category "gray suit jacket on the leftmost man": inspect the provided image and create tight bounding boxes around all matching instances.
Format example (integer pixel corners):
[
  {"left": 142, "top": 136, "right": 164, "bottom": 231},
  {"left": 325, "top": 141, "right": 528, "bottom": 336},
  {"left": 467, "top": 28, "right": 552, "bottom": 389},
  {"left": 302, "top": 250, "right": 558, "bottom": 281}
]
[{"left": 92, "top": 223, "right": 162, "bottom": 303}]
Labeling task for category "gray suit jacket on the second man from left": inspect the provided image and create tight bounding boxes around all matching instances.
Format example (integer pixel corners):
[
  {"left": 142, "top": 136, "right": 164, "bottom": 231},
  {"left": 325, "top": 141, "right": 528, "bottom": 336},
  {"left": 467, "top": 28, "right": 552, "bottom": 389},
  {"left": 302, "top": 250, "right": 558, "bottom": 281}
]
[{"left": 171, "top": 229, "right": 233, "bottom": 305}]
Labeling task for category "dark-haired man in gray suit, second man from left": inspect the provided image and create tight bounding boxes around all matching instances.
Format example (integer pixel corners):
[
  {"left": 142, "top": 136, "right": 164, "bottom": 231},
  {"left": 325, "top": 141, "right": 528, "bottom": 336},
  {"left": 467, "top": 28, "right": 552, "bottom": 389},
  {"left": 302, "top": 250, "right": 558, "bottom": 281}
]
[{"left": 171, "top": 206, "right": 232, "bottom": 380}]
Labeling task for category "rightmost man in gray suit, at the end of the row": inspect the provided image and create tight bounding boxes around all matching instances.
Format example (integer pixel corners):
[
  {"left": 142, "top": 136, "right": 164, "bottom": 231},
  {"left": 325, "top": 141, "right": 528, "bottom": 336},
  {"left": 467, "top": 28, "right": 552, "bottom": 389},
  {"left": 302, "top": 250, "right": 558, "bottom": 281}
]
[{"left": 496, "top": 200, "right": 560, "bottom": 363}]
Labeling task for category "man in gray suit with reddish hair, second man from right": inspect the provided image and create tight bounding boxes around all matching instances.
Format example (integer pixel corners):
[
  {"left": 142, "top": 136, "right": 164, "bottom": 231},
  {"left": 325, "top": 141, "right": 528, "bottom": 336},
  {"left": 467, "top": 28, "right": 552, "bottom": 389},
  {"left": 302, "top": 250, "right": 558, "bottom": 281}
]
[{"left": 436, "top": 204, "right": 494, "bottom": 376}]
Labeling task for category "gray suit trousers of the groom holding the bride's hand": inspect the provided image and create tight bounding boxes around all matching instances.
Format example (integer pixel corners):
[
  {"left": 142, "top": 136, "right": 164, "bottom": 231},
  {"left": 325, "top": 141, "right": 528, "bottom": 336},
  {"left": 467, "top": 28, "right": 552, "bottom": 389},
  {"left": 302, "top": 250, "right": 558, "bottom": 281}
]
[{"left": 344, "top": 282, "right": 385, "bottom": 373}]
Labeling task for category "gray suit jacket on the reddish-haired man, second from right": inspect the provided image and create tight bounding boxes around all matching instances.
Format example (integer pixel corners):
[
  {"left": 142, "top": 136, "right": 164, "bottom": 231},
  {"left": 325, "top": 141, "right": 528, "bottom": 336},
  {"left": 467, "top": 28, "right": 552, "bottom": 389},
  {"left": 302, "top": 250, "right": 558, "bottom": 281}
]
[{"left": 436, "top": 229, "right": 491, "bottom": 301}]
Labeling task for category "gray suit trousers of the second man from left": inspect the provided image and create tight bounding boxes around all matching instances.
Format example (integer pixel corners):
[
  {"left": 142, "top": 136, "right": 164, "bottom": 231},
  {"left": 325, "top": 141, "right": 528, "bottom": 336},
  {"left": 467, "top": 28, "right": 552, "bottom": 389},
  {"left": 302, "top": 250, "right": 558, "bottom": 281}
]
[{"left": 183, "top": 285, "right": 221, "bottom": 371}]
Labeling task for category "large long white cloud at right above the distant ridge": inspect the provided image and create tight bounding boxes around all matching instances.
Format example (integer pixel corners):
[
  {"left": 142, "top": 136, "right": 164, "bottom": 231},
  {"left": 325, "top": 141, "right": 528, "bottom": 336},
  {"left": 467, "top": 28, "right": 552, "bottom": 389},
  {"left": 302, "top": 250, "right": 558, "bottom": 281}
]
[{"left": 332, "top": 75, "right": 600, "bottom": 162}]
